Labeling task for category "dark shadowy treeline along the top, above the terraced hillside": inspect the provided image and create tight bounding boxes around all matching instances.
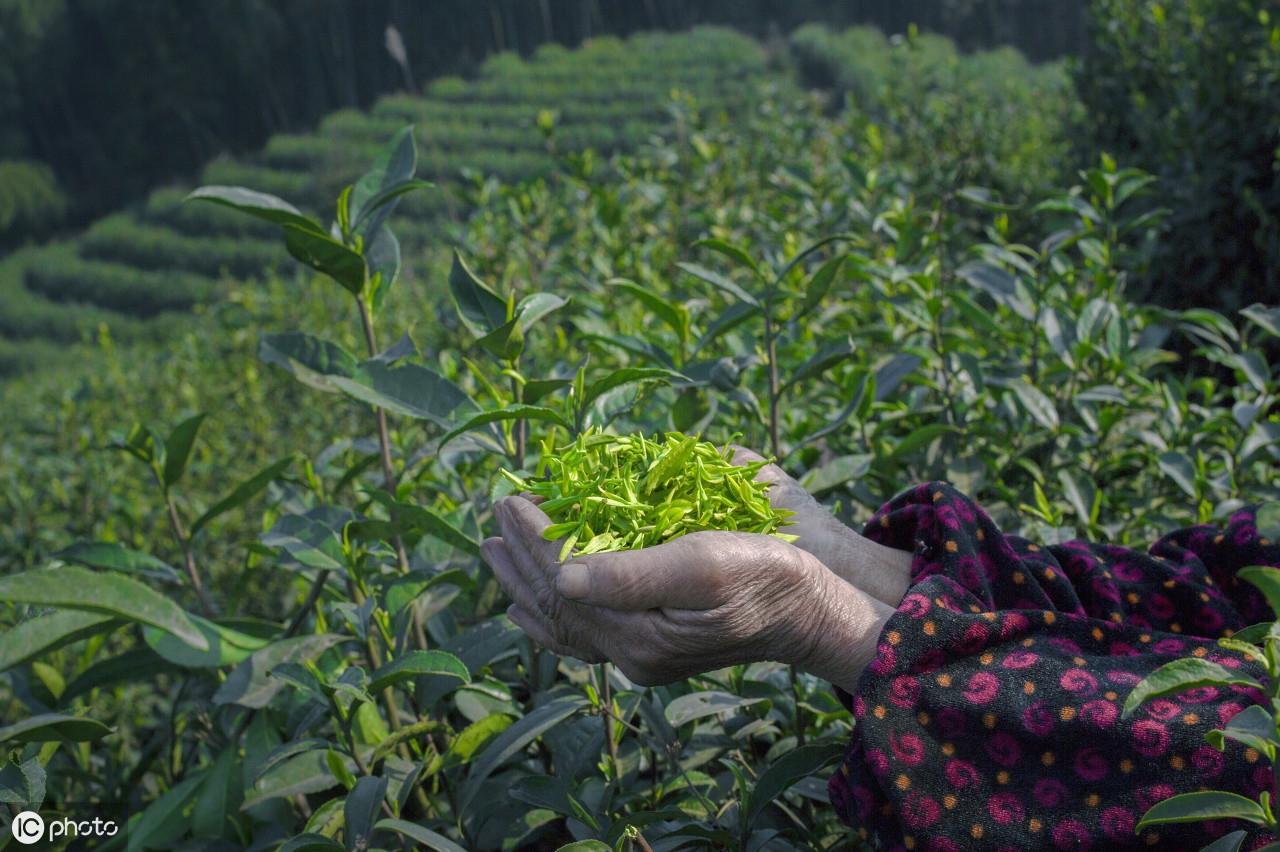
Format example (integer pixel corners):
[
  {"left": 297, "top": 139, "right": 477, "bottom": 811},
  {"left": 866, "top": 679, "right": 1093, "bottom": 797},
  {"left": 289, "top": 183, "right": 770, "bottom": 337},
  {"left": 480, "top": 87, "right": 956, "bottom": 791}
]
[{"left": 0, "top": 0, "right": 1084, "bottom": 242}]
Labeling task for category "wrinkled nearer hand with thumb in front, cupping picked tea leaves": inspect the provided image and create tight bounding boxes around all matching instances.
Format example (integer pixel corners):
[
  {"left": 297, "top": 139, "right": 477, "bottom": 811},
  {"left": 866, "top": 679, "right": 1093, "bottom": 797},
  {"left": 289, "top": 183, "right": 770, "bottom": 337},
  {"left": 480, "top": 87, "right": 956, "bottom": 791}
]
[{"left": 481, "top": 498, "right": 892, "bottom": 687}]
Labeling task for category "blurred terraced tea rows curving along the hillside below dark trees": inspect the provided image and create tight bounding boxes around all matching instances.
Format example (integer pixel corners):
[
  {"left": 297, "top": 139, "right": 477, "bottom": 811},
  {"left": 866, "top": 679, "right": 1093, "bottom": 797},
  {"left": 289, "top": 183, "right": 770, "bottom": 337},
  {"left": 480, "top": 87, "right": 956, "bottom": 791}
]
[{"left": 0, "top": 28, "right": 767, "bottom": 375}]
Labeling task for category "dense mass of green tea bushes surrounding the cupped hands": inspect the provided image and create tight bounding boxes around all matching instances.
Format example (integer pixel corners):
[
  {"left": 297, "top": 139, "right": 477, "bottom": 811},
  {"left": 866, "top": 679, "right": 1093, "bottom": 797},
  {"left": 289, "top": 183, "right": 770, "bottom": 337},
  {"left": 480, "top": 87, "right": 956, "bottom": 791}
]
[{"left": 0, "top": 49, "right": 1280, "bottom": 849}]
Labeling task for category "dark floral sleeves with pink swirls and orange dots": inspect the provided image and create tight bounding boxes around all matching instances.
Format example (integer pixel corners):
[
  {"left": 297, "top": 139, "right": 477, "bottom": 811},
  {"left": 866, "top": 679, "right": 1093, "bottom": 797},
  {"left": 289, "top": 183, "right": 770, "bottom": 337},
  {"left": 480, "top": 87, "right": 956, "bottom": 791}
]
[{"left": 829, "top": 482, "right": 1280, "bottom": 852}]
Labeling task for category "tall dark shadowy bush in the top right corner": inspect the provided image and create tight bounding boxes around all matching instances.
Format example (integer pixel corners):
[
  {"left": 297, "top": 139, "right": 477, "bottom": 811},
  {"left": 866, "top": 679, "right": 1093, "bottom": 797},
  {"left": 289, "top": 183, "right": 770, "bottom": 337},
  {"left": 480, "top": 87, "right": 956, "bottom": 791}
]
[{"left": 1074, "top": 0, "right": 1280, "bottom": 310}]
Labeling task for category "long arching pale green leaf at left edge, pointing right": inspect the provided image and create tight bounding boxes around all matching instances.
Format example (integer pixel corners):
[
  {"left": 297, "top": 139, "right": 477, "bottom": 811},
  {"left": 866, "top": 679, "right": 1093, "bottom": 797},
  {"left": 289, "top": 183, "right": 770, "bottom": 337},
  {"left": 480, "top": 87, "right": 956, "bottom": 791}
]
[{"left": 0, "top": 565, "right": 209, "bottom": 650}]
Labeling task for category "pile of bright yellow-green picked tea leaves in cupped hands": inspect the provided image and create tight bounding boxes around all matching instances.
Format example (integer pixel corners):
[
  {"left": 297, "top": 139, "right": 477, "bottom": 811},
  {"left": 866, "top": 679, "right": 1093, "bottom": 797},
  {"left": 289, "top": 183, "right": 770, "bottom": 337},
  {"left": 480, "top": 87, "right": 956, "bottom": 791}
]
[{"left": 503, "top": 430, "right": 795, "bottom": 559}]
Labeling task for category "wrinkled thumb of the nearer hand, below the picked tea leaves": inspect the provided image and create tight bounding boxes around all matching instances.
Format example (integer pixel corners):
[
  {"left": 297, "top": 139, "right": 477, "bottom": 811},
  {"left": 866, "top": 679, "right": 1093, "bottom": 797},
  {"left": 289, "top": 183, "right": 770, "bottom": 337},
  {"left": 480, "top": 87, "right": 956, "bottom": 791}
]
[{"left": 556, "top": 532, "right": 736, "bottom": 611}]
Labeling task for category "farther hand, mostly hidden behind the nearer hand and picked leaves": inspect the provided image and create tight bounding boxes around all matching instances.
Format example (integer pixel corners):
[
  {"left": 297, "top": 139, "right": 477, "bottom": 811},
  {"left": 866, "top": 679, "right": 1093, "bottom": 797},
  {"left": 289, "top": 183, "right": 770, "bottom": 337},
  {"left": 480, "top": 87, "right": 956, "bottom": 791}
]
[{"left": 732, "top": 446, "right": 911, "bottom": 608}]
